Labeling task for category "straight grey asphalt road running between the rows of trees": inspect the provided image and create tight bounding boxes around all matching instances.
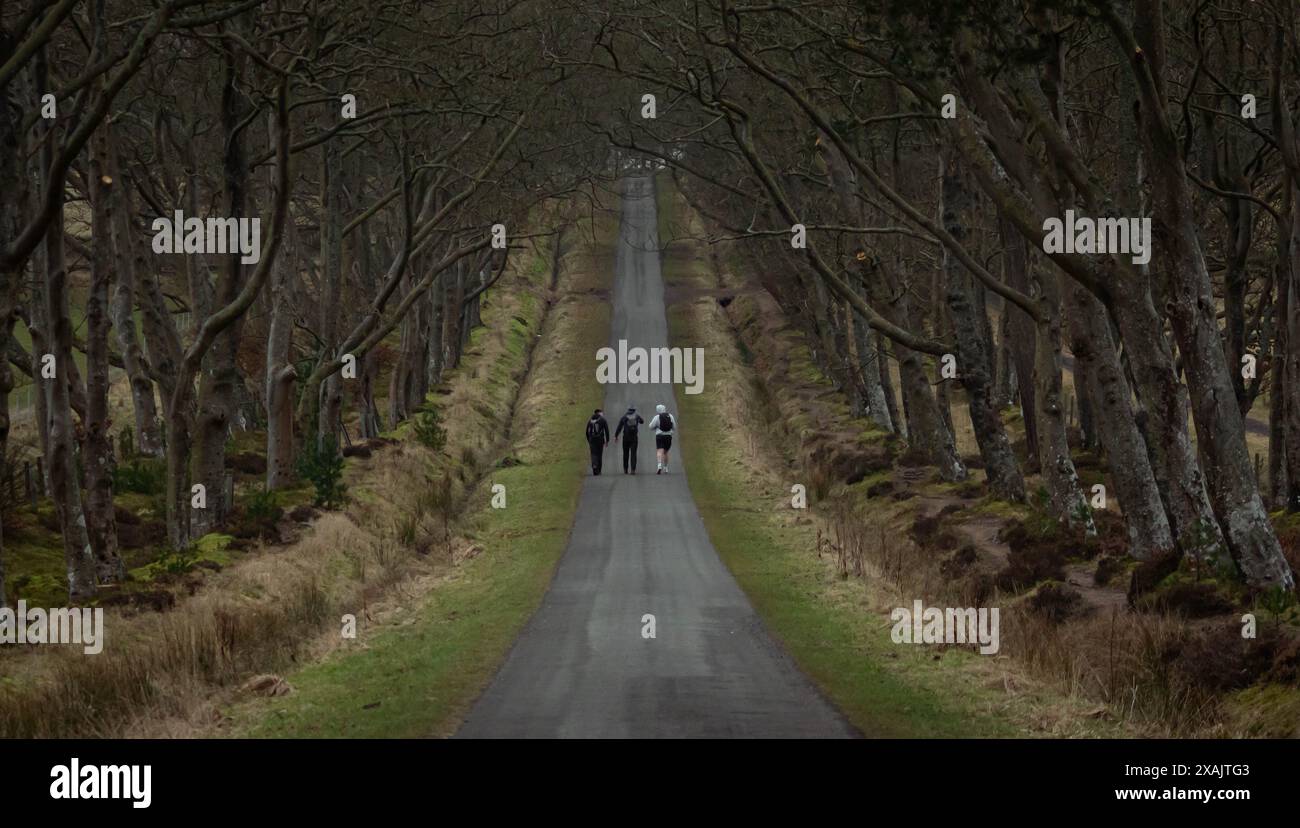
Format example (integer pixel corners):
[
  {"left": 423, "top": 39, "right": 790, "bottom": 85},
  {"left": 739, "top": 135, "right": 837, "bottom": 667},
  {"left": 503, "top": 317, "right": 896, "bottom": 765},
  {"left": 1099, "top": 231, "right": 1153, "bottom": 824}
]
[{"left": 458, "top": 178, "right": 855, "bottom": 738}]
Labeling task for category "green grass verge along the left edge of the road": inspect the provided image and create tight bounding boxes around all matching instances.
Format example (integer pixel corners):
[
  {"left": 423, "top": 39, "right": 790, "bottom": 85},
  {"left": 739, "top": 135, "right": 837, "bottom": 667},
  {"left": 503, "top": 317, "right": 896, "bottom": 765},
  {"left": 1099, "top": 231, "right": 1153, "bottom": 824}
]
[{"left": 231, "top": 248, "right": 608, "bottom": 737}]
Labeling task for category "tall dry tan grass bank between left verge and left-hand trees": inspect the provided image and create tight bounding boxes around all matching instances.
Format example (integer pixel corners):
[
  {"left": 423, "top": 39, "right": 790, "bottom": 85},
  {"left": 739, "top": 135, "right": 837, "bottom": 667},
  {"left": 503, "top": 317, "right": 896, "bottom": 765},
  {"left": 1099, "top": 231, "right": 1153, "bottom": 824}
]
[{"left": 0, "top": 220, "right": 559, "bottom": 738}]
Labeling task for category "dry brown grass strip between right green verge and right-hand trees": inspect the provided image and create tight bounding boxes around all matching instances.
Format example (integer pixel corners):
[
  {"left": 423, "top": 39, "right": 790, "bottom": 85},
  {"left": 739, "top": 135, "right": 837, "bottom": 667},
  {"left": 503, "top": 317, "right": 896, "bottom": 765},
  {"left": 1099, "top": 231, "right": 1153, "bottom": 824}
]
[{"left": 715, "top": 287, "right": 1279, "bottom": 737}]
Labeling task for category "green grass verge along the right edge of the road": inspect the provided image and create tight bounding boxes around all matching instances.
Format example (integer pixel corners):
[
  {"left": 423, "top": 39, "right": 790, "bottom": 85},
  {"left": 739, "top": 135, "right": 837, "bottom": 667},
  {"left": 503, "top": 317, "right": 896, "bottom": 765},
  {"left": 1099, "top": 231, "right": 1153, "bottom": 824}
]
[{"left": 672, "top": 318, "right": 1017, "bottom": 737}]
